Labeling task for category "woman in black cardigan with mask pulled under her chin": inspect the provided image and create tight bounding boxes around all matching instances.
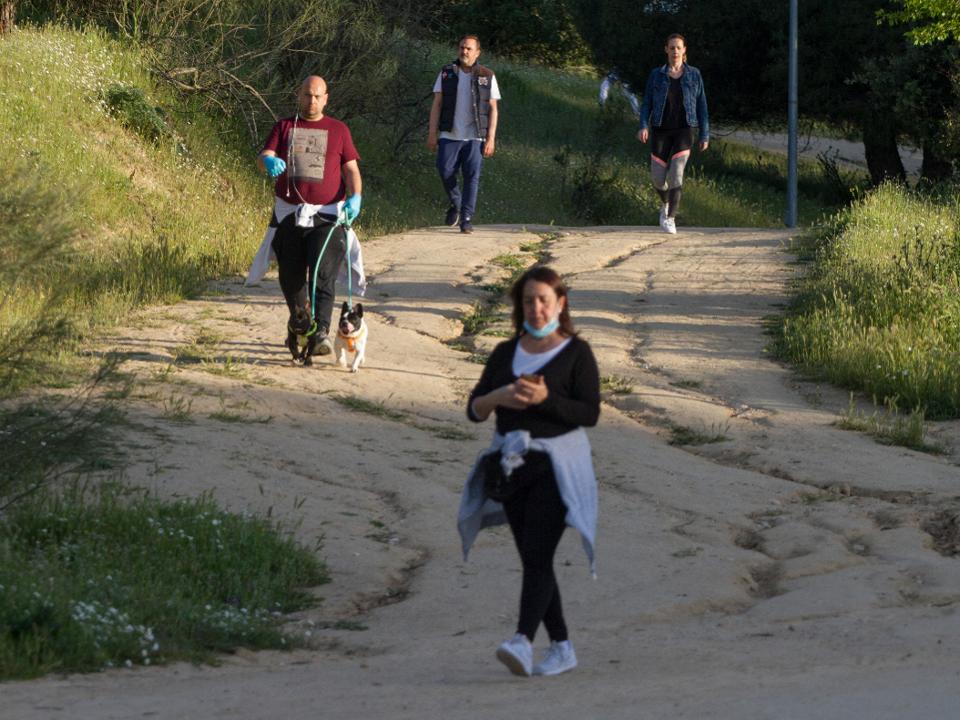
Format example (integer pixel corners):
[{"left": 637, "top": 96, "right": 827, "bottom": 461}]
[{"left": 457, "top": 266, "right": 600, "bottom": 676}]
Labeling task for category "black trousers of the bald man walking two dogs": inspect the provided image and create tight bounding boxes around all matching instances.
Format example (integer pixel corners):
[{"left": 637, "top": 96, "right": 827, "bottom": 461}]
[{"left": 273, "top": 212, "right": 346, "bottom": 334}]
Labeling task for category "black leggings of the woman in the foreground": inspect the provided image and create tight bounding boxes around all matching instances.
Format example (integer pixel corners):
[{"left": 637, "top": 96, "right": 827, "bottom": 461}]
[{"left": 503, "top": 452, "right": 567, "bottom": 642}]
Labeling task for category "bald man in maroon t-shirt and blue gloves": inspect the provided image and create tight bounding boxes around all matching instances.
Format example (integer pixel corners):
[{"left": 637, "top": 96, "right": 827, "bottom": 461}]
[{"left": 257, "top": 75, "right": 362, "bottom": 365}]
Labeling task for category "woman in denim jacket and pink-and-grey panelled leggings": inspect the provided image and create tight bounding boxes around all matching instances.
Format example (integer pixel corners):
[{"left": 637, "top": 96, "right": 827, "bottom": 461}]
[{"left": 637, "top": 34, "right": 710, "bottom": 235}]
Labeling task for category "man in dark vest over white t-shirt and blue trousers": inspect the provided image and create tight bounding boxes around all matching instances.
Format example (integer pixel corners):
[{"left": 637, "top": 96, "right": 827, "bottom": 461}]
[{"left": 427, "top": 35, "right": 500, "bottom": 233}]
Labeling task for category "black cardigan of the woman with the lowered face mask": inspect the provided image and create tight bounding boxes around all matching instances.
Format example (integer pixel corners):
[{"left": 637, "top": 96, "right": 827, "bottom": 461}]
[{"left": 467, "top": 335, "right": 600, "bottom": 438}]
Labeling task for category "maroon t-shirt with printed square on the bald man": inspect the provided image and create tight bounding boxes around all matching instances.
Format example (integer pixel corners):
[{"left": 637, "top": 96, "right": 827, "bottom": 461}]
[{"left": 263, "top": 116, "right": 360, "bottom": 205}]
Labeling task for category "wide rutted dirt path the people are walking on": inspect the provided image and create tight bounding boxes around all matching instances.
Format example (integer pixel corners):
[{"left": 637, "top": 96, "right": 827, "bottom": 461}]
[{"left": 0, "top": 222, "right": 960, "bottom": 720}]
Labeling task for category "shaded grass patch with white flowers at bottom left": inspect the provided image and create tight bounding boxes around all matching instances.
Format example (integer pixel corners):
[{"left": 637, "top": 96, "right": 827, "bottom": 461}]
[{"left": 0, "top": 487, "right": 327, "bottom": 679}]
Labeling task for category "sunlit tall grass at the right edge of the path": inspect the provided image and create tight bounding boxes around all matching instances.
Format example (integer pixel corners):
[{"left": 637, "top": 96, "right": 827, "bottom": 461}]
[{"left": 775, "top": 186, "right": 960, "bottom": 419}]
